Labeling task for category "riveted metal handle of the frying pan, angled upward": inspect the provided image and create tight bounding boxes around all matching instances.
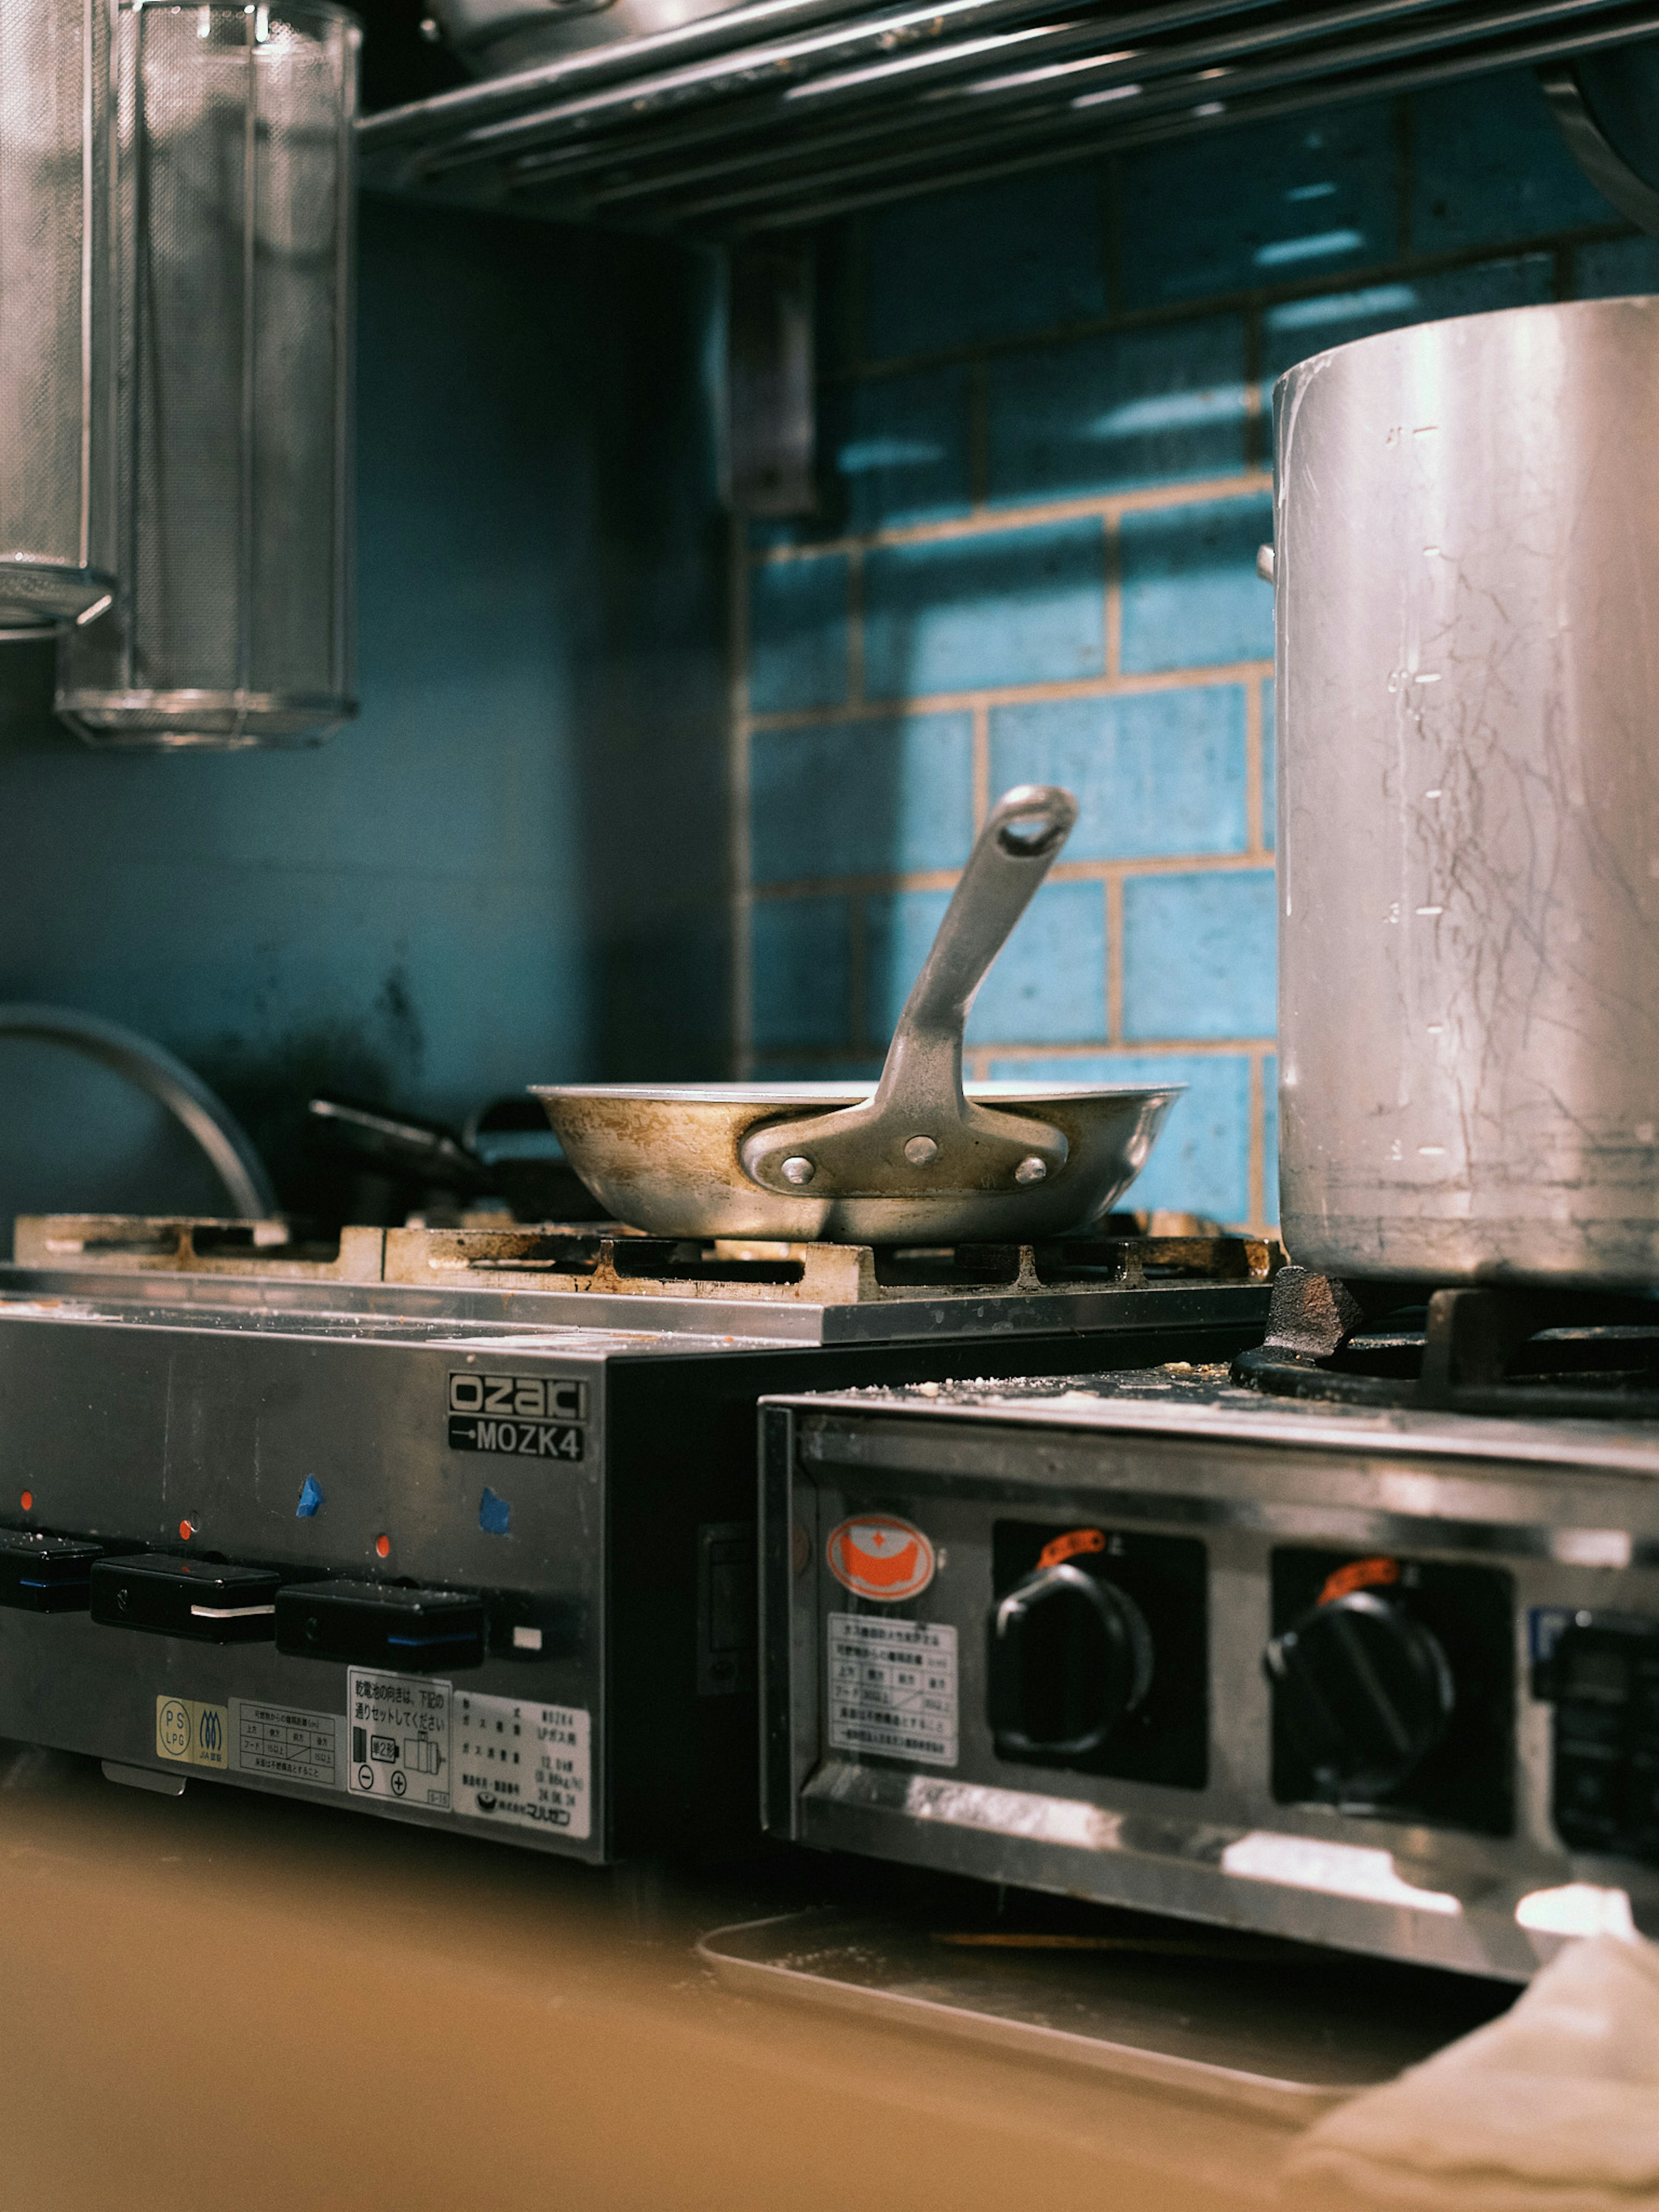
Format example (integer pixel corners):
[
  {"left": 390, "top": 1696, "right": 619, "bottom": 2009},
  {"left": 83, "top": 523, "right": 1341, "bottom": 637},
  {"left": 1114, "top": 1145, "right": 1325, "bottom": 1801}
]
[{"left": 739, "top": 783, "right": 1077, "bottom": 1199}]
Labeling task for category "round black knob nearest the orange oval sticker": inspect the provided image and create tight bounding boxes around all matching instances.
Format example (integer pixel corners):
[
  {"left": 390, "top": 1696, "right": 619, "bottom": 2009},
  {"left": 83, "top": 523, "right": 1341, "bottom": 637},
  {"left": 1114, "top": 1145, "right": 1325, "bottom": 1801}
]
[{"left": 991, "top": 1566, "right": 1153, "bottom": 1758}]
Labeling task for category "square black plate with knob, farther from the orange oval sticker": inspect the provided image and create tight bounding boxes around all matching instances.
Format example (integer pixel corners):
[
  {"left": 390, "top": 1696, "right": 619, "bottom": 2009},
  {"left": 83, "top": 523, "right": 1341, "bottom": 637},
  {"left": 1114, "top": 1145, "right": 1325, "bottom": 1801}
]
[{"left": 1265, "top": 1548, "right": 1515, "bottom": 1836}]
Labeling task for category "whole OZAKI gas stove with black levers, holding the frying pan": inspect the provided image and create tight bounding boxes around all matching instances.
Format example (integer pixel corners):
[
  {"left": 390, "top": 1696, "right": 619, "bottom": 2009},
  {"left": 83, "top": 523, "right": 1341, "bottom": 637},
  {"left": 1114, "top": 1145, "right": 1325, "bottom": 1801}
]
[{"left": 0, "top": 1217, "right": 1272, "bottom": 1860}]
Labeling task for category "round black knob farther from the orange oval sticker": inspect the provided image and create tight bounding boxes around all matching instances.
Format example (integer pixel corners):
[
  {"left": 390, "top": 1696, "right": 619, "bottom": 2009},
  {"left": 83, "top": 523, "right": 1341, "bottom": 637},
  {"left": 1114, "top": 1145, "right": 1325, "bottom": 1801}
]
[{"left": 1268, "top": 1590, "right": 1456, "bottom": 1796}]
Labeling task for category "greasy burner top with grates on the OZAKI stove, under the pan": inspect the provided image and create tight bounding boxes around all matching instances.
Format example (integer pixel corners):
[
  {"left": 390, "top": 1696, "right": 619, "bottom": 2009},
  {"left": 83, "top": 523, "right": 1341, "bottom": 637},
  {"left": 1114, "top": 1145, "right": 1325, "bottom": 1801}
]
[{"left": 0, "top": 1214, "right": 1278, "bottom": 1345}]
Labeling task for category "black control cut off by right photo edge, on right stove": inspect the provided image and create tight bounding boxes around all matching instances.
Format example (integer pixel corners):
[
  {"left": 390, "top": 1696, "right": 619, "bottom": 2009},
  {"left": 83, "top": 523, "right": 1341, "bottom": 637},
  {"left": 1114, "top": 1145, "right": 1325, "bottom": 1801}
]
[{"left": 1548, "top": 1612, "right": 1659, "bottom": 1865}]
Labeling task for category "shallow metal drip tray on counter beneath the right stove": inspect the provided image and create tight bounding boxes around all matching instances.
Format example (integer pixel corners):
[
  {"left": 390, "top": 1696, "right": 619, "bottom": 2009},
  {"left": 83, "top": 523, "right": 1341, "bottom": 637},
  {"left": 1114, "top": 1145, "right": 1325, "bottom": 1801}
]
[{"left": 697, "top": 1907, "right": 1515, "bottom": 2121}]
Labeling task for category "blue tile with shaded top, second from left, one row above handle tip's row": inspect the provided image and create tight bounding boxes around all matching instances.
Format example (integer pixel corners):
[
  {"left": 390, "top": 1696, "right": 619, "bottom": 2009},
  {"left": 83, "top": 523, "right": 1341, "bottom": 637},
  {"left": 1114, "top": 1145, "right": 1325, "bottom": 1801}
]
[{"left": 865, "top": 520, "right": 1106, "bottom": 699}]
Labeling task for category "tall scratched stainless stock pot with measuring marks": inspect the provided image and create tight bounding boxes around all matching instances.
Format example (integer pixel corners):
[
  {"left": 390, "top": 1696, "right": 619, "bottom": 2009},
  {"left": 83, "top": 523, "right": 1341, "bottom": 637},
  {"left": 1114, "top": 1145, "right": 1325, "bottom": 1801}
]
[{"left": 1274, "top": 299, "right": 1659, "bottom": 1285}]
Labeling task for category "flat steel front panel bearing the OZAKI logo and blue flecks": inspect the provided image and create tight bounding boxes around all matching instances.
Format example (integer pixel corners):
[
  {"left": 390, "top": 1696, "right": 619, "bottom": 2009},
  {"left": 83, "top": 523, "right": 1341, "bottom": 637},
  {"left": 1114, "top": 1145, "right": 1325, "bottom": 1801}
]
[{"left": 0, "top": 1303, "right": 610, "bottom": 1860}]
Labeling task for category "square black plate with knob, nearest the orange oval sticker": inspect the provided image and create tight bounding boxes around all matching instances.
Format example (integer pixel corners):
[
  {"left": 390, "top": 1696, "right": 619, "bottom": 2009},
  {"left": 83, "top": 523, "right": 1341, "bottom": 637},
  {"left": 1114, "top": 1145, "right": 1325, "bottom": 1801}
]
[{"left": 987, "top": 1519, "right": 1210, "bottom": 1789}]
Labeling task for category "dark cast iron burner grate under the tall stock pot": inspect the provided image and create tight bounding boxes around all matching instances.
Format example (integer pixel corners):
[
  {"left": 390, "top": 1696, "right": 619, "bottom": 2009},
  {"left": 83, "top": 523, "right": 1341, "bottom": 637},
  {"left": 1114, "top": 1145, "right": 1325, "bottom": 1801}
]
[{"left": 1232, "top": 1265, "right": 1659, "bottom": 1420}]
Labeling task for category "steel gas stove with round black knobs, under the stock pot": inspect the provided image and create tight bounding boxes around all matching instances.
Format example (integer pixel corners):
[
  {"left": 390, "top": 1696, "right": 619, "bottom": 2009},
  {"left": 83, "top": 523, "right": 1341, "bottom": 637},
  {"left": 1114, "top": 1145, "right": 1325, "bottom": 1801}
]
[{"left": 761, "top": 1327, "right": 1659, "bottom": 1980}]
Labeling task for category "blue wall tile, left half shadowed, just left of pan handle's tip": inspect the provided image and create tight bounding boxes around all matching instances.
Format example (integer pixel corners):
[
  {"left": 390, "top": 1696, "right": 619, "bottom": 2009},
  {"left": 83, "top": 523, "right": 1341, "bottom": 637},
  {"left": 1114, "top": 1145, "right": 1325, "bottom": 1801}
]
[{"left": 750, "top": 715, "right": 973, "bottom": 883}]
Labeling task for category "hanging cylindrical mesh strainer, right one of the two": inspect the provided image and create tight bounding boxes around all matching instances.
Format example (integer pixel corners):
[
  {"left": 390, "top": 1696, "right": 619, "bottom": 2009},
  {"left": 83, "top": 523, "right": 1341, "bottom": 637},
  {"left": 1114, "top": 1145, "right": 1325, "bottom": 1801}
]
[{"left": 57, "top": 0, "right": 358, "bottom": 748}]
